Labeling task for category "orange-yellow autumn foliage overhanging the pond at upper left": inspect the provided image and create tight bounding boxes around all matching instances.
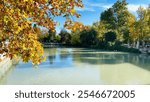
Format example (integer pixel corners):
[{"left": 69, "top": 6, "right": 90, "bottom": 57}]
[{"left": 0, "top": 0, "right": 83, "bottom": 64}]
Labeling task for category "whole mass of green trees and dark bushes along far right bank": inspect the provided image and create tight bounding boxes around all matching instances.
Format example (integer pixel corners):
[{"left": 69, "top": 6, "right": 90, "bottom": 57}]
[{"left": 39, "top": 0, "right": 150, "bottom": 53}]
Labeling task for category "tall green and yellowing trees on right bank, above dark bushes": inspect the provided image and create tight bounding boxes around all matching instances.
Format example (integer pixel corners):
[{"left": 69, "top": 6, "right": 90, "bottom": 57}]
[{"left": 93, "top": 0, "right": 150, "bottom": 49}]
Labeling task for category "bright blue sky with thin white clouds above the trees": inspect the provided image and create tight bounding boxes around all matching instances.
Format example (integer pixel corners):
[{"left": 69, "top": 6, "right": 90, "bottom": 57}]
[{"left": 54, "top": 0, "right": 150, "bottom": 33}]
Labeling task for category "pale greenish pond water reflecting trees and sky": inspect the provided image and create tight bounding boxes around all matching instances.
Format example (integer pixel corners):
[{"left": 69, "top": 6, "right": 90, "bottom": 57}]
[{"left": 0, "top": 48, "right": 150, "bottom": 85}]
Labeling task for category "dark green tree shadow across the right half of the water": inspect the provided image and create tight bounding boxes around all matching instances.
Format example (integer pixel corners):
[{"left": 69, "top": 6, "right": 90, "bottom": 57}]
[{"left": 73, "top": 52, "right": 150, "bottom": 71}]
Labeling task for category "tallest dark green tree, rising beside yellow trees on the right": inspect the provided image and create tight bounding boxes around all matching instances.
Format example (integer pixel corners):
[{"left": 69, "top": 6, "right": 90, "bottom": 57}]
[{"left": 100, "top": 0, "right": 129, "bottom": 42}]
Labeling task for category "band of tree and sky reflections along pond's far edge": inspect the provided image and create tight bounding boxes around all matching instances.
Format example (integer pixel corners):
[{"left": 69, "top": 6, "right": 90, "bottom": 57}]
[{"left": 43, "top": 48, "right": 150, "bottom": 71}]
